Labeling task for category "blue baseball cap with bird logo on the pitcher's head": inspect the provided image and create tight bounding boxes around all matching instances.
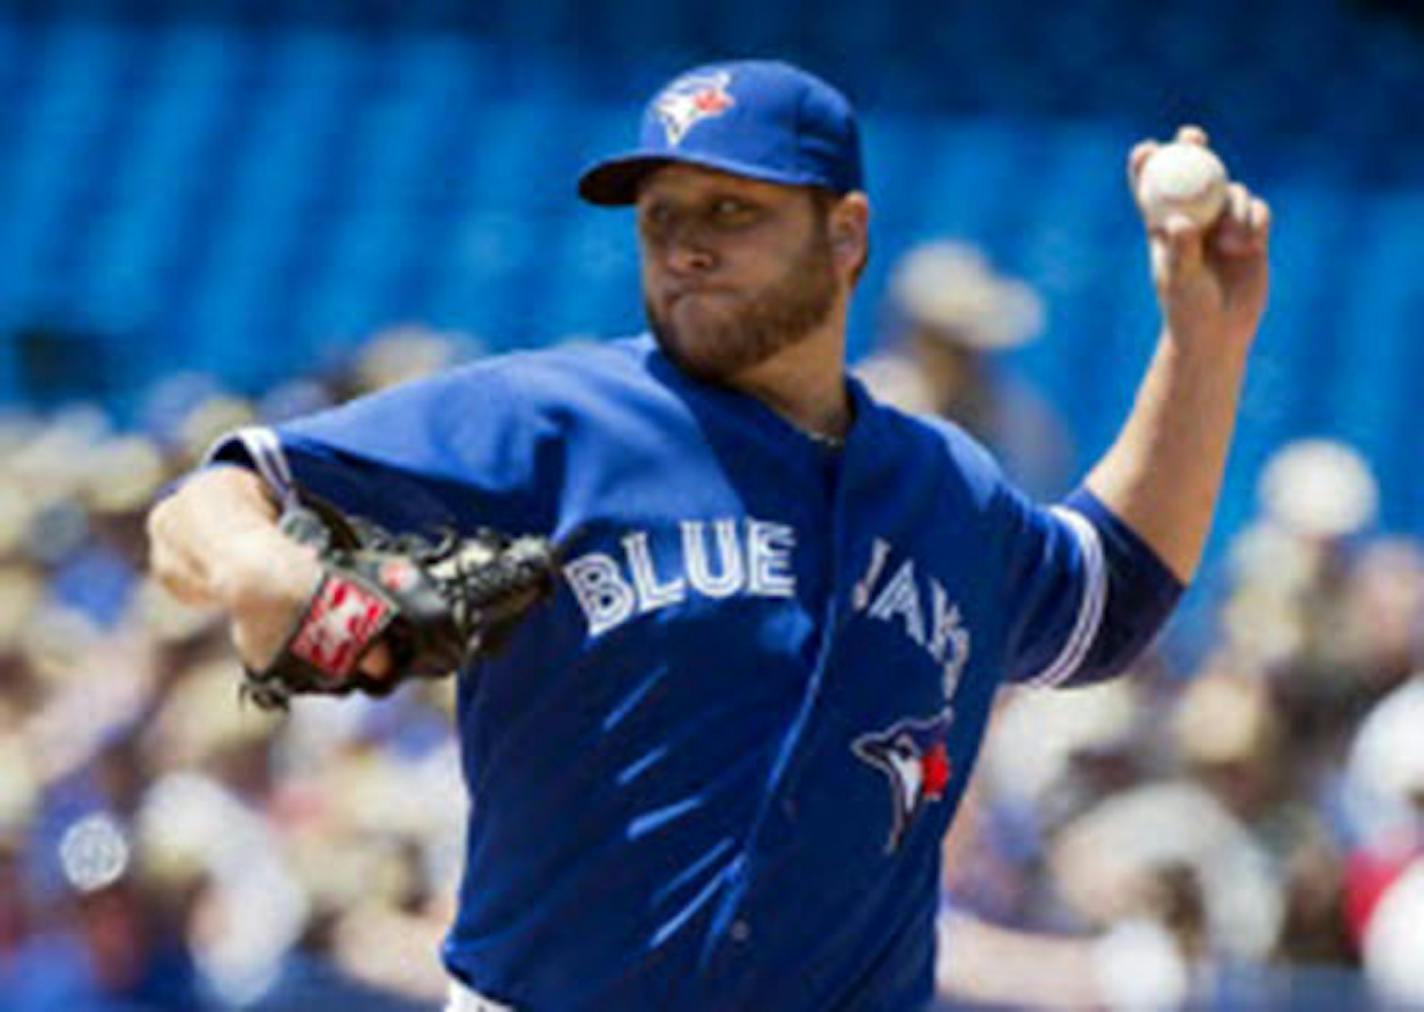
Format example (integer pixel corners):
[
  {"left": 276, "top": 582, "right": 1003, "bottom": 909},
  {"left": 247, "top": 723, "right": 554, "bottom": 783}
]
[{"left": 578, "top": 60, "right": 864, "bottom": 206}]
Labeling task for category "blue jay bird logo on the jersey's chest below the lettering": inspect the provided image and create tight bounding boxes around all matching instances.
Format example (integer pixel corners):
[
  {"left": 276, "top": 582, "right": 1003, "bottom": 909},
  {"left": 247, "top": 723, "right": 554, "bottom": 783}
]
[{"left": 850, "top": 709, "right": 954, "bottom": 854}]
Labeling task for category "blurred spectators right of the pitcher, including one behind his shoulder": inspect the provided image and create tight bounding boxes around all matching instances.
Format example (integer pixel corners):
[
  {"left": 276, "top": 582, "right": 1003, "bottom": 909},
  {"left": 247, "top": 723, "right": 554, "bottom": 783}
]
[{"left": 862, "top": 243, "right": 1424, "bottom": 1008}]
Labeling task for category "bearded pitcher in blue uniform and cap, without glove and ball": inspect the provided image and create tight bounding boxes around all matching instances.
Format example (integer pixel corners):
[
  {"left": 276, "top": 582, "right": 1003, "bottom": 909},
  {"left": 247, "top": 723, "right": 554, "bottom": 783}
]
[{"left": 150, "top": 61, "right": 1267, "bottom": 1011}]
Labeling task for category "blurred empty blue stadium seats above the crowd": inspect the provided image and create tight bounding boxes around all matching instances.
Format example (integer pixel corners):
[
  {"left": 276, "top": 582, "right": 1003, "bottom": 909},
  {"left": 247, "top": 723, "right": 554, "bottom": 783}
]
[{"left": 0, "top": 0, "right": 1424, "bottom": 546}]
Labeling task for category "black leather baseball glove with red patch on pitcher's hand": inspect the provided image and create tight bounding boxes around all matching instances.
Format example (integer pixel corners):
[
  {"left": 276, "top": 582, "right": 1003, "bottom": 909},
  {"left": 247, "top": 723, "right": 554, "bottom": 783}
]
[{"left": 241, "top": 497, "right": 558, "bottom": 710}]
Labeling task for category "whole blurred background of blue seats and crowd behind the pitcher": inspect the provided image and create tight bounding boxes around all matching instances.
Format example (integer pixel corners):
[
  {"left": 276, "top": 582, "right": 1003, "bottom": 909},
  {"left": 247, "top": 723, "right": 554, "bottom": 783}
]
[{"left": 0, "top": 0, "right": 1424, "bottom": 1012}]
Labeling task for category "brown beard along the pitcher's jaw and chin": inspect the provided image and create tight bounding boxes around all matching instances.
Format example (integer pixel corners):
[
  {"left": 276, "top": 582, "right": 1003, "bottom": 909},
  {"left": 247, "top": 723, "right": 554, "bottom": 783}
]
[{"left": 644, "top": 222, "right": 836, "bottom": 383}]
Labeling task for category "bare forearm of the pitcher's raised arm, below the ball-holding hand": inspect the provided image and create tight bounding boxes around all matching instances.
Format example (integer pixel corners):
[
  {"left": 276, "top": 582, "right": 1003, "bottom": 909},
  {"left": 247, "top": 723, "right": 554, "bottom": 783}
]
[{"left": 1087, "top": 334, "right": 1247, "bottom": 584}]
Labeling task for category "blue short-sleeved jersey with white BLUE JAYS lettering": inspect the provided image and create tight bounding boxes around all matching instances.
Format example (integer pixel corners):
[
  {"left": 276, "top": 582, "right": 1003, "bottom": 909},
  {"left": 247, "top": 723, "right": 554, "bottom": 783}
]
[{"left": 210, "top": 337, "right": 1144, "bottom": 1012}]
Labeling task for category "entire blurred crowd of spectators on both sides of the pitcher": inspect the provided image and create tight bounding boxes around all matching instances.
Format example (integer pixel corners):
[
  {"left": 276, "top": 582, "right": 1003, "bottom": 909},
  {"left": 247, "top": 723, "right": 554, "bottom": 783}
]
[{"left": 0, "top": 249, "right": 1424, "bottom": 1009}]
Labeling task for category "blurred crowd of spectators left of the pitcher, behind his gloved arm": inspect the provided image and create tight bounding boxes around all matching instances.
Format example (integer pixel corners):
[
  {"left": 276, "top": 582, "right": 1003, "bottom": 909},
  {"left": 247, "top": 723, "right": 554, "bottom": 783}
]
[{"left": 0, "top": 327, "right": 477, "bottom": 1012}]
